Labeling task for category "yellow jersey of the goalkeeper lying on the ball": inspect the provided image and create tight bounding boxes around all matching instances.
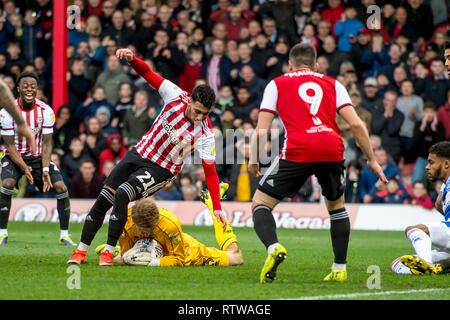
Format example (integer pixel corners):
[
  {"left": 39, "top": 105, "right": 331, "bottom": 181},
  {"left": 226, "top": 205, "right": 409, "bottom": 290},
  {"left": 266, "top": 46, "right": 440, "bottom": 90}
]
[{"left": 119, "top": 208, "right": 229, "bottom": 266}]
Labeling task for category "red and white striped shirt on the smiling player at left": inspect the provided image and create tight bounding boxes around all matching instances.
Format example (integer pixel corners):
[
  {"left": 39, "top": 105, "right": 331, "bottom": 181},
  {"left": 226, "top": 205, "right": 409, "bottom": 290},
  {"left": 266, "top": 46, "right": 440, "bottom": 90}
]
[{"left": 0, "top": 98, "right": 55, "bottom": 156}]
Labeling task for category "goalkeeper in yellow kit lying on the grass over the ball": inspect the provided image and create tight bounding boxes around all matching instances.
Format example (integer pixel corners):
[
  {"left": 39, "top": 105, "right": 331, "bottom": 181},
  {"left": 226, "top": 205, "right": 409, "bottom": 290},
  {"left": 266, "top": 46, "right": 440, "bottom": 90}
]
[{"left": 96, "top": 183, "right": 243, "bottom": 266}]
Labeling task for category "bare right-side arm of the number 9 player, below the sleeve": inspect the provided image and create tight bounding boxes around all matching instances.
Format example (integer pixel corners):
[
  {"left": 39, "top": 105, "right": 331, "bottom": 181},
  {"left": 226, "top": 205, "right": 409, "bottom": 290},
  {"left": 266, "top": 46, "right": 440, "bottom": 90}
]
[{"left": 338, "top": 105, "right": 388, "bottom": 183}]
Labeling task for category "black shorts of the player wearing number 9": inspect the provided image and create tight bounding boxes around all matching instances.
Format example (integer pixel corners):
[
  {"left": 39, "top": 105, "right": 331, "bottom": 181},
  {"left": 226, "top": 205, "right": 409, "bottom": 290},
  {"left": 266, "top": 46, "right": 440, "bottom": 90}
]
[{"left": 258, "top": 158, "right": 345, "bottom": 201}]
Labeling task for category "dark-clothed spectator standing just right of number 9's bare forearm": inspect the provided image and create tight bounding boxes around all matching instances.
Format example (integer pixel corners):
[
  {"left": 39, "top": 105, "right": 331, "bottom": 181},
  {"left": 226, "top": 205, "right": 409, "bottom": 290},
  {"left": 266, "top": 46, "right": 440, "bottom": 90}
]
[{"left": 372, "top": 91, "right": 405, "bottom": 163}]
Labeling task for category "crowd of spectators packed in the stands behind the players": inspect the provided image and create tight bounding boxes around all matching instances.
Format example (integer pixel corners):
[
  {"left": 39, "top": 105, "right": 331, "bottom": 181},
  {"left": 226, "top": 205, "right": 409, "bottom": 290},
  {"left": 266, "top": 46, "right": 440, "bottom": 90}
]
[{"left": 0, "top": 0, "right": 450, "bottom": 209}]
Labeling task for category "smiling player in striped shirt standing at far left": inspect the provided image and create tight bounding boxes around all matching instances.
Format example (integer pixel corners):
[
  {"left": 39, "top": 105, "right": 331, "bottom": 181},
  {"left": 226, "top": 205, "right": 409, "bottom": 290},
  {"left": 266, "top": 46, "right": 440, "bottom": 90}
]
[{"left": 0, "top": 72, "right": 75, "bottom": 246}]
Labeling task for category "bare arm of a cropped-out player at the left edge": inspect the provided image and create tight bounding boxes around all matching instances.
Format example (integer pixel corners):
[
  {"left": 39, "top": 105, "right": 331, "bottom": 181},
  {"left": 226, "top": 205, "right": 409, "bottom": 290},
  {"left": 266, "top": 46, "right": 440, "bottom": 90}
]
[{"left": 0, "top": 79, "right": 37, "bottom": 154}]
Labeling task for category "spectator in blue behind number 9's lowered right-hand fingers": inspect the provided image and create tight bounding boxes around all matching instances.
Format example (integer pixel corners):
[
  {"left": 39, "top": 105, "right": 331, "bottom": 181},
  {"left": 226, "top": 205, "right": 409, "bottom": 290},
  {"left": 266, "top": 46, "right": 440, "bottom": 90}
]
[{"left": 359, "top": 148, "right": 405, "bottom": 203}]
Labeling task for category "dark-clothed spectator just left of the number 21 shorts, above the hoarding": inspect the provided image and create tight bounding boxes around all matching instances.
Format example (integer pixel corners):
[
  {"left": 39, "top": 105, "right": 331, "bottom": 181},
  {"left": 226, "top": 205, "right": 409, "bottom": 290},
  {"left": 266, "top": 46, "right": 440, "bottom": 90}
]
[{"left": 69, "top": 159, "right": 103, "bottom": 199}]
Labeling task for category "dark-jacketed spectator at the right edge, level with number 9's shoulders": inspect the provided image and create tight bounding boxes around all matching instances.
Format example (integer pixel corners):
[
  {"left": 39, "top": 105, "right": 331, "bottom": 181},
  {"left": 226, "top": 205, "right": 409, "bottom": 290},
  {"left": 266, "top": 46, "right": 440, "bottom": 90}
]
[{"left": 416, "top": 58, "right": 450, "bottom": 110}]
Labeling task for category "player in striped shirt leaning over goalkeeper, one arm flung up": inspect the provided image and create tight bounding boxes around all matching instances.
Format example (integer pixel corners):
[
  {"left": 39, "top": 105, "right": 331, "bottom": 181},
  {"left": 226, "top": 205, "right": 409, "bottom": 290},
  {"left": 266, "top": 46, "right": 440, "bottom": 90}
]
[{"left": 67, "top": 49, "right": 227, "bottom": 266}]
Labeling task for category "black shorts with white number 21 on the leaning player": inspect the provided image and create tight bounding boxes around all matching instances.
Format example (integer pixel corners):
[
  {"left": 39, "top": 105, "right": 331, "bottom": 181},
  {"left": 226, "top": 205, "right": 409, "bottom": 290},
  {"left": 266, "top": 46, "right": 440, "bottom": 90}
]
[{"left": 105, "top": 148, "right": 175, "bottom": 199}]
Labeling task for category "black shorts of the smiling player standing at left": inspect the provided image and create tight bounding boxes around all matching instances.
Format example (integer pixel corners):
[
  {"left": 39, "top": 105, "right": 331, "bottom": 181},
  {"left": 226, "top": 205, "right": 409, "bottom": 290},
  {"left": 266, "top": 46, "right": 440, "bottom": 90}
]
[{"left": 2, "top": 156, "right": 63, "bottom": 191}]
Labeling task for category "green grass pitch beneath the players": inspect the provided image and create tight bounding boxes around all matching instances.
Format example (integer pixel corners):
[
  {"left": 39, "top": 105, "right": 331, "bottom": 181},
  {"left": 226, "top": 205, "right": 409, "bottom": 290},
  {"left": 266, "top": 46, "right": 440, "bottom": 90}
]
[{"left": 0, "top": 222, "right": 450, "bottom": 300}]
